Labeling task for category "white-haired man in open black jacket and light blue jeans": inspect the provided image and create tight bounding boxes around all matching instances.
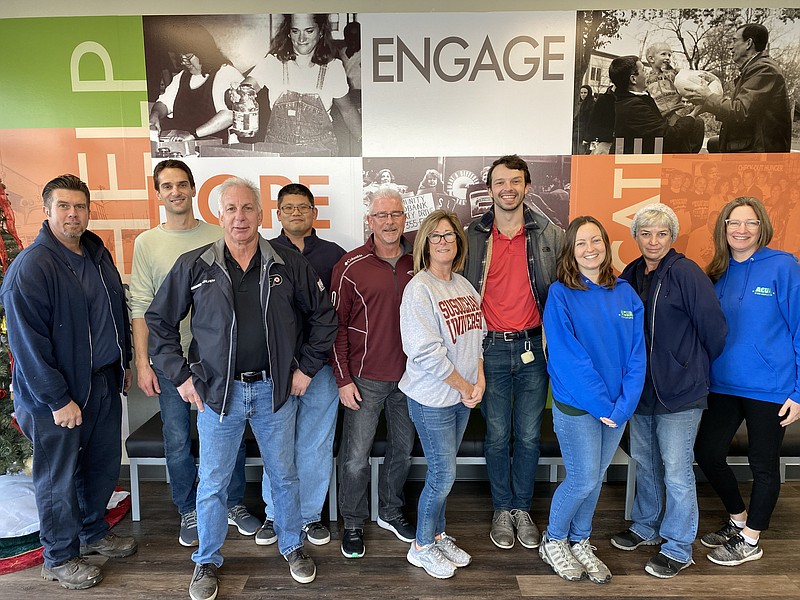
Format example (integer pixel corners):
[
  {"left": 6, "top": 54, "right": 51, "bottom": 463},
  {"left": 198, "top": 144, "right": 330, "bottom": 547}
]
[{"left": 145, "top": 177, "right": 336, "bottom": 600}]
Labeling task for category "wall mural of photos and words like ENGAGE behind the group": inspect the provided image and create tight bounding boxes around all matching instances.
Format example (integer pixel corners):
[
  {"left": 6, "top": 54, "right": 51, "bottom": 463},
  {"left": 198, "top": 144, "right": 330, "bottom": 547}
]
[{"left": 0, "top": 8, "right": 800, "bottom": 276}]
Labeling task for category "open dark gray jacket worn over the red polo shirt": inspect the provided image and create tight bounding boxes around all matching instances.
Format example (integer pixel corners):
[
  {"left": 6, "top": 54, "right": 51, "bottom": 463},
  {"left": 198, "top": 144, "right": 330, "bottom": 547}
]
[{"left": 462, "top": 206, "right": 564, "bottom": 315}]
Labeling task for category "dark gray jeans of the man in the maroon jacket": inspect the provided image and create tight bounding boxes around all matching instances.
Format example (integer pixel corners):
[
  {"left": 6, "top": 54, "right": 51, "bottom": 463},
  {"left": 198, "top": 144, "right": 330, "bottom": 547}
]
[{"left": 339, "top": 377, "right": 414, "bottom": 529}]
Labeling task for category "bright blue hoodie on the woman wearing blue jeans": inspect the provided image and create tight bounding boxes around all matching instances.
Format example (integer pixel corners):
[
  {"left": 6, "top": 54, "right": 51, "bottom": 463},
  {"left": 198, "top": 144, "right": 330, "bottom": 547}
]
[{"left": 544, "top": 279, "right": 647, "bottom": 427}]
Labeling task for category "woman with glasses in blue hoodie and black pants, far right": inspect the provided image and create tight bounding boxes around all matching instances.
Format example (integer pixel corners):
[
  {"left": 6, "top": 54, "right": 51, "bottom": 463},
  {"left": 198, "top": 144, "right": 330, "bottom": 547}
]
[{"left": 695, "top": 198, "right": 800, "bottom": 566}]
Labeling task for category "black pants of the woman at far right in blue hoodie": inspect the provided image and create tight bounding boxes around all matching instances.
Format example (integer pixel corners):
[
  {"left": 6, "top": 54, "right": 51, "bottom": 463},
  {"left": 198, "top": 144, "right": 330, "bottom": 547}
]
[{"left": 694, "top": 392, "right": 786, "bottom": 531}]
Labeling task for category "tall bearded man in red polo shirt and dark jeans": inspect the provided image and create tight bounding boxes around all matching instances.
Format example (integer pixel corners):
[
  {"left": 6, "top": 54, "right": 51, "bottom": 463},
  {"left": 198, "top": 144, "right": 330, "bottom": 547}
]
[{"left": 464, "top": 155, "right": 564, "bottom": 549}]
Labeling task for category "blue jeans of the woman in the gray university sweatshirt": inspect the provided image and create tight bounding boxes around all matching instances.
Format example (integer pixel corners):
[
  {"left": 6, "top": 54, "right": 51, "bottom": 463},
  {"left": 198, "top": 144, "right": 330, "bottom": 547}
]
[{"left": 408, "top": 398, "right": 470, "bottom": 546}]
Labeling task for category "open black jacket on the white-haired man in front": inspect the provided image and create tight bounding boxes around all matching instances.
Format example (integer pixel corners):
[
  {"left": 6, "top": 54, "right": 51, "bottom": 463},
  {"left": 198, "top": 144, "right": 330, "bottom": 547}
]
[{"left": 145, "top": 237, "right": 336, "bottom": 418}]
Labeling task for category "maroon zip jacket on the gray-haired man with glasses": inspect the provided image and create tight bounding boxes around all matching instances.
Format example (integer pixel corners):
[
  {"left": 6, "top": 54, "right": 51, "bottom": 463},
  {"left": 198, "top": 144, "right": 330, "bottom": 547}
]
[{"left": 331, "top": 236, "right": 414, "bottom": 387}]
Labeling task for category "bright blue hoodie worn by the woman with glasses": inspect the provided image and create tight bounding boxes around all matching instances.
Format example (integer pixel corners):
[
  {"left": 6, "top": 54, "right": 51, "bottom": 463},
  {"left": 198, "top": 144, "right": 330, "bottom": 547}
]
[{"left": 711, "top": 248, "right": 800, "bottom": 404}]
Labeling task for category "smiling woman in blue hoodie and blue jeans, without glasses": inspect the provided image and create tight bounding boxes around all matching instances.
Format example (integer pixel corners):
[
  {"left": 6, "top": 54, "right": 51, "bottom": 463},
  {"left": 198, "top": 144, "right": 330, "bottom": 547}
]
[{"left": 539, "top": 217, "right": 647, "bottom": 583}]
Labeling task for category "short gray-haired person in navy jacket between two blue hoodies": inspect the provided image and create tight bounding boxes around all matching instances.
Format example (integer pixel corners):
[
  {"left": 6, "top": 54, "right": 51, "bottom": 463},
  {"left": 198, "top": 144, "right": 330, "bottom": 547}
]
[{"left": 611, "top": 204, "right": 728, "bottom": 579}]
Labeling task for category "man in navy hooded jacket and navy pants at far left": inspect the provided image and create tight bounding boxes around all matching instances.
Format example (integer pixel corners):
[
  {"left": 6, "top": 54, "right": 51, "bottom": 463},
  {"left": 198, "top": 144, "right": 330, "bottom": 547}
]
[{"left": 0, "top": 175, "right": 137, "bottom": 589}]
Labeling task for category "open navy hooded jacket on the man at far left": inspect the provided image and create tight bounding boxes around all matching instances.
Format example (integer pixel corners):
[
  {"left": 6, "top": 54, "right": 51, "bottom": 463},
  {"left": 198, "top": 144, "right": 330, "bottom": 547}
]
[{"left": 0, "top": 221, "right": 131, "bottom": 411}]
